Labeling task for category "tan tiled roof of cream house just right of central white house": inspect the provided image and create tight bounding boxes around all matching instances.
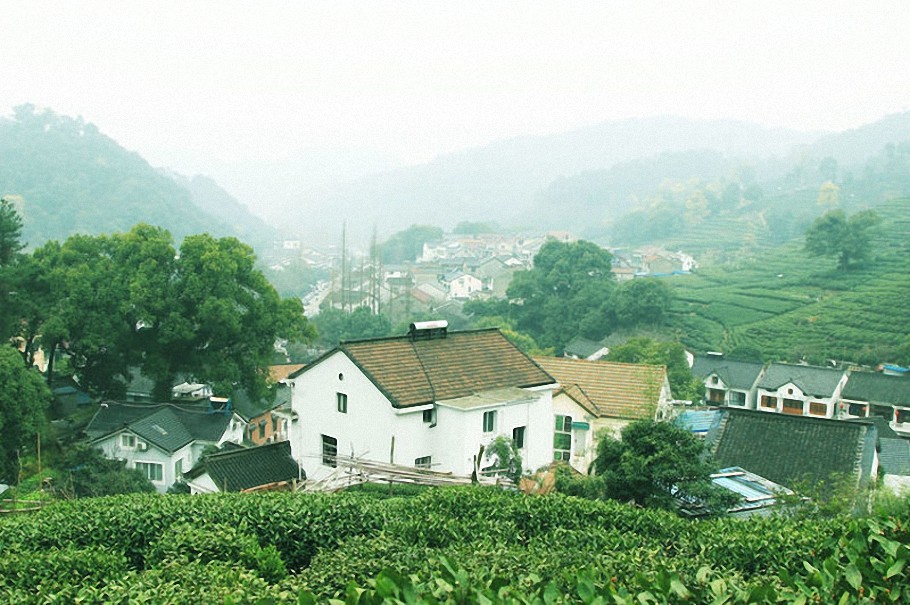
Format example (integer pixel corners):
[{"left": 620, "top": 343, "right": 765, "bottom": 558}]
[{"left": 534, "top": 357, "right": 667, "bottom": 420}]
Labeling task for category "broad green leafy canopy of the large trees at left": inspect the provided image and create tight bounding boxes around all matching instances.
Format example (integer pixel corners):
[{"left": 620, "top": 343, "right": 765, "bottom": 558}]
[{"left": 11, "top": 225, "right": 313, "bottom": 398}]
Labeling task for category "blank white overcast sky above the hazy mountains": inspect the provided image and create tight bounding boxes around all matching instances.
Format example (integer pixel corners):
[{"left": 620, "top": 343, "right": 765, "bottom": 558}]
[{"left": 0, "top": 0, "right": 910, "bottom": 196}]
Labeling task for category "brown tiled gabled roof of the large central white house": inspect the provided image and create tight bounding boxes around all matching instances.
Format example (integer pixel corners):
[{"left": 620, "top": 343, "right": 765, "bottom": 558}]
[{"left": 292, "top": 328, "right": 555, "bottom": 408}]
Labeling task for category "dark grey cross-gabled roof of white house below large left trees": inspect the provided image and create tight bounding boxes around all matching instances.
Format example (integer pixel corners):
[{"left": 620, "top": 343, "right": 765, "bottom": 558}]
[{"left": 85, "top": 401, "right": 232, "bottom": 452}]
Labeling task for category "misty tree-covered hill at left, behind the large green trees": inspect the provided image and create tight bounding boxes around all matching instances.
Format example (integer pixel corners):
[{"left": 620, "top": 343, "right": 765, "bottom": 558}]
[{"left": 0, "top": 106, "right": 278, "bottom": 247}]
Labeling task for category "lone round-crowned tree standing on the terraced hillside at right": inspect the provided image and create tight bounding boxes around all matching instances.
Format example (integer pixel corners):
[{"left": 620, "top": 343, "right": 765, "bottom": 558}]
[{"left": 805, "top": 210, "right": 881, "bottom": 271}]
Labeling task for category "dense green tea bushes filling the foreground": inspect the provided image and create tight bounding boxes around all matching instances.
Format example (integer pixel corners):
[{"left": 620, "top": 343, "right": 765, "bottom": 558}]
[{"left": 0, "top": 488, "right": 910, "bottom": 604}]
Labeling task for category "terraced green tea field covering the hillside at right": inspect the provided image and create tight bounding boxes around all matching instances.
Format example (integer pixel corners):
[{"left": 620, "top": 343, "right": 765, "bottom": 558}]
[{"left": 669, "top": 198, "right": 910, "bottom": 364}]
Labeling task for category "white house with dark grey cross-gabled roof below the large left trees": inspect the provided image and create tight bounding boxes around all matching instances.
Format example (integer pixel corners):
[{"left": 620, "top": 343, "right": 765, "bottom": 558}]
[{"left": 85, "top": 401, "right": 244, "bottom": 493}]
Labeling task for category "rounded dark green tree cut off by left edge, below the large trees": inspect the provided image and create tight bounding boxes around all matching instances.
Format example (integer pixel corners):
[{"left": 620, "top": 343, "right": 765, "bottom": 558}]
[{"left": 0, "top": 344, "right": 51, "bottom": 483}]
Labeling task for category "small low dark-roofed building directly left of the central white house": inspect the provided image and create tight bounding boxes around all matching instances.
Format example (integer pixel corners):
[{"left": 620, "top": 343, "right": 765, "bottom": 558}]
[{"left": 184, "top": 441, "right": 305, "bottom": 494}]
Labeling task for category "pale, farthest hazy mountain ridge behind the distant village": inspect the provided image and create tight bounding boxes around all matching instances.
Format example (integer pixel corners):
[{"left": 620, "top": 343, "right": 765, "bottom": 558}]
[{"left": 288, "top": 117, "right": 818, "bottom": 240}]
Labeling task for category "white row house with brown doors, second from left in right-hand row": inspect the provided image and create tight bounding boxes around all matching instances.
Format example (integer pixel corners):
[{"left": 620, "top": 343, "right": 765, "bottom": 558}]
[{"left": 756, "top": 363, "right": 847, "bottom": 418}]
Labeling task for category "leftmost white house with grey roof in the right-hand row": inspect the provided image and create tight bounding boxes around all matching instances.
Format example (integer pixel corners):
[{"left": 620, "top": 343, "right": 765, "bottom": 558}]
[{"left": 692, "top": 354, "right": 764, "bottom": 410}]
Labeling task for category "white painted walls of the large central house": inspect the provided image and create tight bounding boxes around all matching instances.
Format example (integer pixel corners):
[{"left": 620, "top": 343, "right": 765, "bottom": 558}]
[{"left": 289, "top": 351, "right": 555, "bottom": 480}]
